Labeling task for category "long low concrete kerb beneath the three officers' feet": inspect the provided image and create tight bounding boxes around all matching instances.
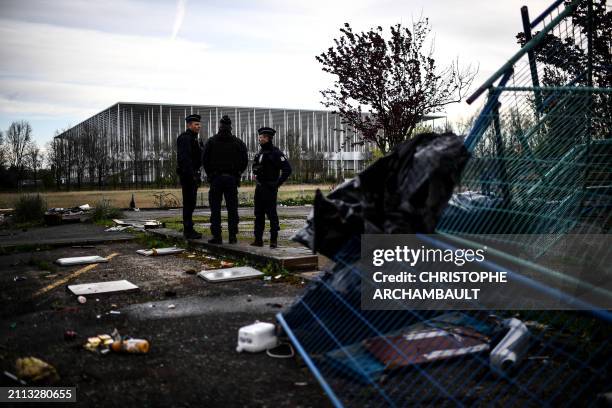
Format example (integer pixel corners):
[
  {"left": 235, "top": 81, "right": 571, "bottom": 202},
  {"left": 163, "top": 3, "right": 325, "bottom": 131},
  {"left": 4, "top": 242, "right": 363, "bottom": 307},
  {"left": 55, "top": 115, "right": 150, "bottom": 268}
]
[{"left": 147, "top": 228, "right": 319, "bottom": 271}]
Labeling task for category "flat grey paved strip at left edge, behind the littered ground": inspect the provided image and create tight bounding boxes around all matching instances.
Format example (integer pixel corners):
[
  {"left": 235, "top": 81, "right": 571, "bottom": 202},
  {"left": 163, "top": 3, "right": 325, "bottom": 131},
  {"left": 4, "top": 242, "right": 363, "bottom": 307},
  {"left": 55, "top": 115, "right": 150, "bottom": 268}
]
[{"left": 0, "top": 224, "right": 135, "bottom": 250}]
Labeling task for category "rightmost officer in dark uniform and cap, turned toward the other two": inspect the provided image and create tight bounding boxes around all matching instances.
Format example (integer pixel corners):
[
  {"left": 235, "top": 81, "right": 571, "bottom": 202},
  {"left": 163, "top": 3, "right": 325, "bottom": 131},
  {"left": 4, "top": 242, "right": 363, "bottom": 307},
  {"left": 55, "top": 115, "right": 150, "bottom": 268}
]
[{"left": 251, "top": 127, "right": 291, "bottom": 248}]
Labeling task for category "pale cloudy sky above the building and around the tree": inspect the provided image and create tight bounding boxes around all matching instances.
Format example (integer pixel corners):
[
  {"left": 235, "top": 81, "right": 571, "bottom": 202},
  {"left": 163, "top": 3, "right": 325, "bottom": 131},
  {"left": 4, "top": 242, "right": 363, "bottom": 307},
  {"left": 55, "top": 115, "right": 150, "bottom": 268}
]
[{"left": 0, "top": 0, "right": 552, "bottom": 145}]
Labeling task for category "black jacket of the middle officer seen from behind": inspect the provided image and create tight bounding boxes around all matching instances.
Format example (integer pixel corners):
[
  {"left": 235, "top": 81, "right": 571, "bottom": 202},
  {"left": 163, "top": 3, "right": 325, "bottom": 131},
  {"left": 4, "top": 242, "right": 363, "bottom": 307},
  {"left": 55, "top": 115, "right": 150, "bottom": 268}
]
[{"left": 202, "top": 131, "right": 249, "bottom": 177}]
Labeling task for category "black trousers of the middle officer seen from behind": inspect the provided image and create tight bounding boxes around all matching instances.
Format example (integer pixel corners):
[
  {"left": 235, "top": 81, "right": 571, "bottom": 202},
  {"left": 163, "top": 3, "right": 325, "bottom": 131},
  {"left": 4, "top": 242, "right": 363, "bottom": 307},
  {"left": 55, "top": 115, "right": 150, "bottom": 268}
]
[{"left": 208, "top": 174, "right": 239, "bottom": 237}]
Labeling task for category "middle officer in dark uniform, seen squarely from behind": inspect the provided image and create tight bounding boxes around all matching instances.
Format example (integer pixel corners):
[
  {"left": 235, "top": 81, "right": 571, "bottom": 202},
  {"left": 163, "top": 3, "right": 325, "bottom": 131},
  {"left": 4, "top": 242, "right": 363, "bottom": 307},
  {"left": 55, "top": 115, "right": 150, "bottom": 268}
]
[{"left": 202, "top": 115, "right": 249, "bottom": 244}]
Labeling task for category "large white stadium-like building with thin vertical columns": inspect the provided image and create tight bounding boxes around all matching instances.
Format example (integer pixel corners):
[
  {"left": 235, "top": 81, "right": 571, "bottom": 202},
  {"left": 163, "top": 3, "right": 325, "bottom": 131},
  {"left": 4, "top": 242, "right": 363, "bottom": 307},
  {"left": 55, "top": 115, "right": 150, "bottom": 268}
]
[{"left": 56, "top": 102, "right": 367, "bottom": 183}]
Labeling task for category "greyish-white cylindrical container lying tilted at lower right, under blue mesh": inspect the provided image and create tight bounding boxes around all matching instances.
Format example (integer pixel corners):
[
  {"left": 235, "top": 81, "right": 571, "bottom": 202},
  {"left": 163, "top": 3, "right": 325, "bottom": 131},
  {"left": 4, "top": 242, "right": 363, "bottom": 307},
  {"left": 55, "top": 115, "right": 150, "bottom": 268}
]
[{"left": 489, "top": 317, "right": 529, "bottom": 373}]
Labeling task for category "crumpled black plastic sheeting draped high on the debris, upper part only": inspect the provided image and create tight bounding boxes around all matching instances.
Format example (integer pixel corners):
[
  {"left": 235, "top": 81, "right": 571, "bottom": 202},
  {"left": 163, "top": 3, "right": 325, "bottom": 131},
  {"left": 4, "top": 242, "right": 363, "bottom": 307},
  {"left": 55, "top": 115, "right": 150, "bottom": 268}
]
[{"left": 293, "top": 133, "right": 469, "bottom": 258}]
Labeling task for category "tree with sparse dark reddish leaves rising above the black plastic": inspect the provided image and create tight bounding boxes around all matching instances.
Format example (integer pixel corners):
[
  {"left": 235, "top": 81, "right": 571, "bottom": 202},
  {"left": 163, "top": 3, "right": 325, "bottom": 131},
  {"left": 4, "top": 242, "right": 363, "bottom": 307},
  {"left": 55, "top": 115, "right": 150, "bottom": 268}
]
[{"left": 316, "top": 19, "right": 476, "bottom": 153}]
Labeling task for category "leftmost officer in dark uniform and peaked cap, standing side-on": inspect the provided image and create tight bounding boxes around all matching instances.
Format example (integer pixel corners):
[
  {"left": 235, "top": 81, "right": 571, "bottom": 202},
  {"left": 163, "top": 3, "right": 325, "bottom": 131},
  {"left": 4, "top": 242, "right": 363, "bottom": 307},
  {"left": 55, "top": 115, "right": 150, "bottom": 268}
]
[{"left": 176, "top": 115, "right": 202, "bottom": 239}]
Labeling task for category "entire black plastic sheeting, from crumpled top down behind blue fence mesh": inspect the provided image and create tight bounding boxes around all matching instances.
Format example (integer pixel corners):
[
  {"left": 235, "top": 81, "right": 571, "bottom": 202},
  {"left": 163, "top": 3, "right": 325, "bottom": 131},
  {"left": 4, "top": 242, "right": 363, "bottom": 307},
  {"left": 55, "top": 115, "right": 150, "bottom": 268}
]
[{"left": 283, "top": 133, "right": 469, "bottom": 352}]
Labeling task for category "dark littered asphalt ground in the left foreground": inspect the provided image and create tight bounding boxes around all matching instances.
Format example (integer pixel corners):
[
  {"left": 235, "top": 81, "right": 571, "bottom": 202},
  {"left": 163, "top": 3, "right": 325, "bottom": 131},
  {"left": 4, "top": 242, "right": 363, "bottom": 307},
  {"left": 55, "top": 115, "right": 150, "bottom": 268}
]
[{"left": 0, "top": 242, "right": 329, "bottom": 407}]
